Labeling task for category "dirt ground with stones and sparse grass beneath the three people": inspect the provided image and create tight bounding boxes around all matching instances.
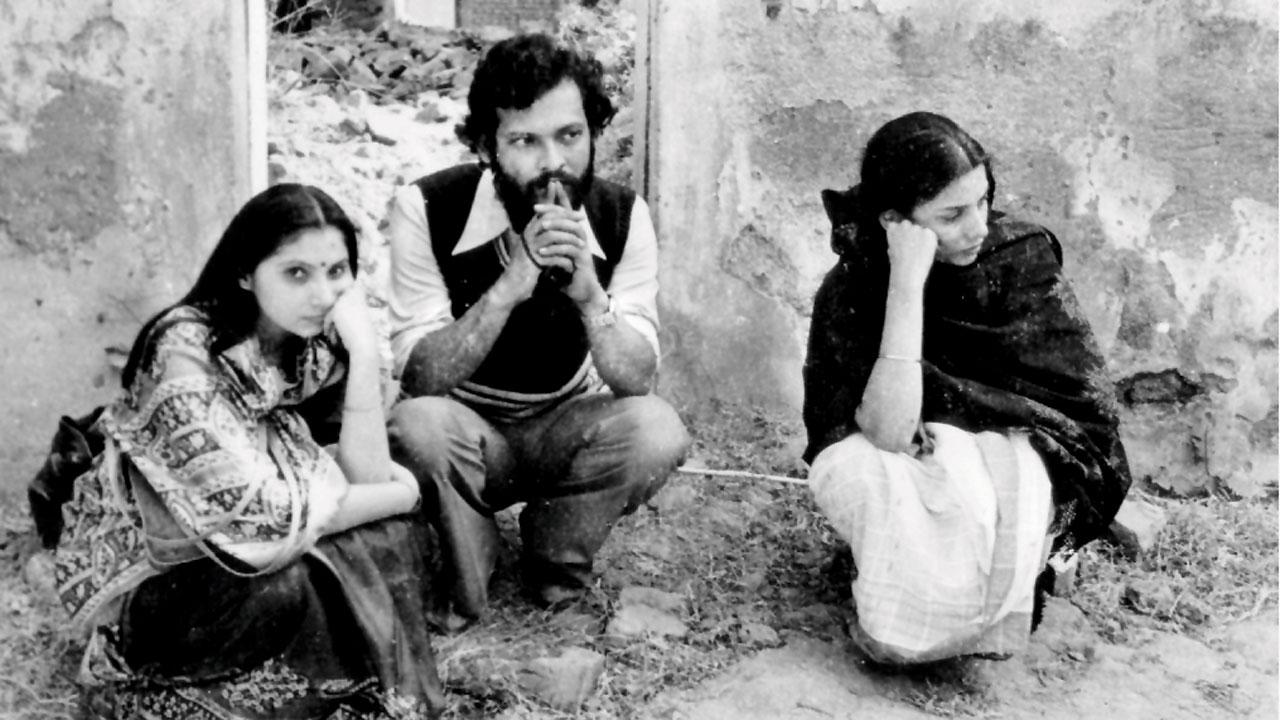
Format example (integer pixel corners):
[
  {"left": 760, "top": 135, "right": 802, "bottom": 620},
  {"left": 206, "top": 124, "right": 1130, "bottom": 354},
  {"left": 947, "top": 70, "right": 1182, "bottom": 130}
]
[{"left": 0, "top": 422, "right": 1280, "bottom": 720}]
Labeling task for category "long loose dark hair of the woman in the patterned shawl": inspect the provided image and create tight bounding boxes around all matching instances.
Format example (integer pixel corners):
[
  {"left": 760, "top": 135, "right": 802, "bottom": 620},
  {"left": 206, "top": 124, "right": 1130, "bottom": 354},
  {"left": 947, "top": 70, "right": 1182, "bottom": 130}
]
[{"left": 120, "top": 183, "right": 358, "bottom": 388}]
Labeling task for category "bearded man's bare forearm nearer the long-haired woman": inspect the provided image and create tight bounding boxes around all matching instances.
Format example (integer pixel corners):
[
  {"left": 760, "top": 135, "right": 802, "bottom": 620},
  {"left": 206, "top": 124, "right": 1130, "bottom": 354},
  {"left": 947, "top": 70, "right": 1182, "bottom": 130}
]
[{"left": 401, "top": 290, "right": 515, "bottom": 397}]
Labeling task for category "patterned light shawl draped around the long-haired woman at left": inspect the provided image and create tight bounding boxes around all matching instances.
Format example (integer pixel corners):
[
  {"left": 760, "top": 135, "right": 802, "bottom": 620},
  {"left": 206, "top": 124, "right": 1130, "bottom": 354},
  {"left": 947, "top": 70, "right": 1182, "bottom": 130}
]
[{"left": 56, "top": 306, "right": 343, "bottom": 624}]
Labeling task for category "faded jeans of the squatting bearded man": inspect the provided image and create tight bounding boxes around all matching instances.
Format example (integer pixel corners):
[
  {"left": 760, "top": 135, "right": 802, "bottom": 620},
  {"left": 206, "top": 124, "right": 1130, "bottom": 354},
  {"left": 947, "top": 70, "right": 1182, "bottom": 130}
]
[{"left": 389, "top": 393, "right": 689, "bottom": 618}]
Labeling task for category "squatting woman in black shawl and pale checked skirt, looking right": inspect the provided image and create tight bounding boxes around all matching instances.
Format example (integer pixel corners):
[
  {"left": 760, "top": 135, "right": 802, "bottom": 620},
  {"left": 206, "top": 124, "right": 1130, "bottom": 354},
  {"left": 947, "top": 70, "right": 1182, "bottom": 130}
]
[{"left": 804, "top": 113, "right": 1130, "bottom": 664}]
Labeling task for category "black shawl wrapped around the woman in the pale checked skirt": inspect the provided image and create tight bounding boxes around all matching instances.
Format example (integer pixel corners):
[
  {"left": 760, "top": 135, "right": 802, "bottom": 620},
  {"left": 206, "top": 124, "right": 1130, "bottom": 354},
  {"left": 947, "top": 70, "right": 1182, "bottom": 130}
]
[{"left": 804, "top": 191, "right": 1130, "bottom": 548}]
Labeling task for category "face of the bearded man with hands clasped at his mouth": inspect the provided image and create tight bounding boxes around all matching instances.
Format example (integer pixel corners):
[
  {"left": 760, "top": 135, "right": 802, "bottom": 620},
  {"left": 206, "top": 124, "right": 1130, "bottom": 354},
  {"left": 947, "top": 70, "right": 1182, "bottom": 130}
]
[{"left": 486, "top": 78, "right": 595, "bottom": 231}]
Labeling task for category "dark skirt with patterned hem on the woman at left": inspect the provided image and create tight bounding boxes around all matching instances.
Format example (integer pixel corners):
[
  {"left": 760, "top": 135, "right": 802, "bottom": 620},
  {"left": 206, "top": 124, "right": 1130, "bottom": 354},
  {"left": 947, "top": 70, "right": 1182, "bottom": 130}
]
[{"left": 86, "top": 516, "right": 443, "bottom": 720}]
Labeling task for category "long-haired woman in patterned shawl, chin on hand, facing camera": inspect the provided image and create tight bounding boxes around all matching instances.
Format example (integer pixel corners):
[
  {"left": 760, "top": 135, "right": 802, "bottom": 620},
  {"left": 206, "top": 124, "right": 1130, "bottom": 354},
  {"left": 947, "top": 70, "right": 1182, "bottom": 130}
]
[{"left": 55, "top": 184, "right": 443, "bottom": 720}]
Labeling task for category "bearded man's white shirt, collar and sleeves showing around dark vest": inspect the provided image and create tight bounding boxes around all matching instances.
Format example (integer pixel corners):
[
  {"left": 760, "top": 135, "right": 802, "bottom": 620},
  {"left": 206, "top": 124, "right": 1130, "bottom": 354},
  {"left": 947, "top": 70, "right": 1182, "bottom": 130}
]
[{"left": 387, "top": 170, "right": 659, "bottom": 377}]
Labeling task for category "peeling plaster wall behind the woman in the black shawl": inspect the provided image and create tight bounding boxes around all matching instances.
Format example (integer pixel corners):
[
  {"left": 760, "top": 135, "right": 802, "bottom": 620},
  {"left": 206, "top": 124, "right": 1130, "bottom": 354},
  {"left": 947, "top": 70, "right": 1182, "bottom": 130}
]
[{"left": 641, "top": 0, "right": 1277, "bottom": 495}]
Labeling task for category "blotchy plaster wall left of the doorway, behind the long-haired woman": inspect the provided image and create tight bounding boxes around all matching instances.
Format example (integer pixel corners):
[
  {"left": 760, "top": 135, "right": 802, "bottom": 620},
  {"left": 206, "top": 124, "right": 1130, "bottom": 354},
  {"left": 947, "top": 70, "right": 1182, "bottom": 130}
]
[{"left": 0, "top": 0, "right": 265, "bottom": 489}]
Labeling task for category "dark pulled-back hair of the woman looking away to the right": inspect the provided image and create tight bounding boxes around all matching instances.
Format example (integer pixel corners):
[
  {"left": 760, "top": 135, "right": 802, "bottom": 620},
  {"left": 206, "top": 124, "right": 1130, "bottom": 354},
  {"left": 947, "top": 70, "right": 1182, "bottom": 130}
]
[{"left": 822, "top": 111, "right": 996, "bottom": 252}]
